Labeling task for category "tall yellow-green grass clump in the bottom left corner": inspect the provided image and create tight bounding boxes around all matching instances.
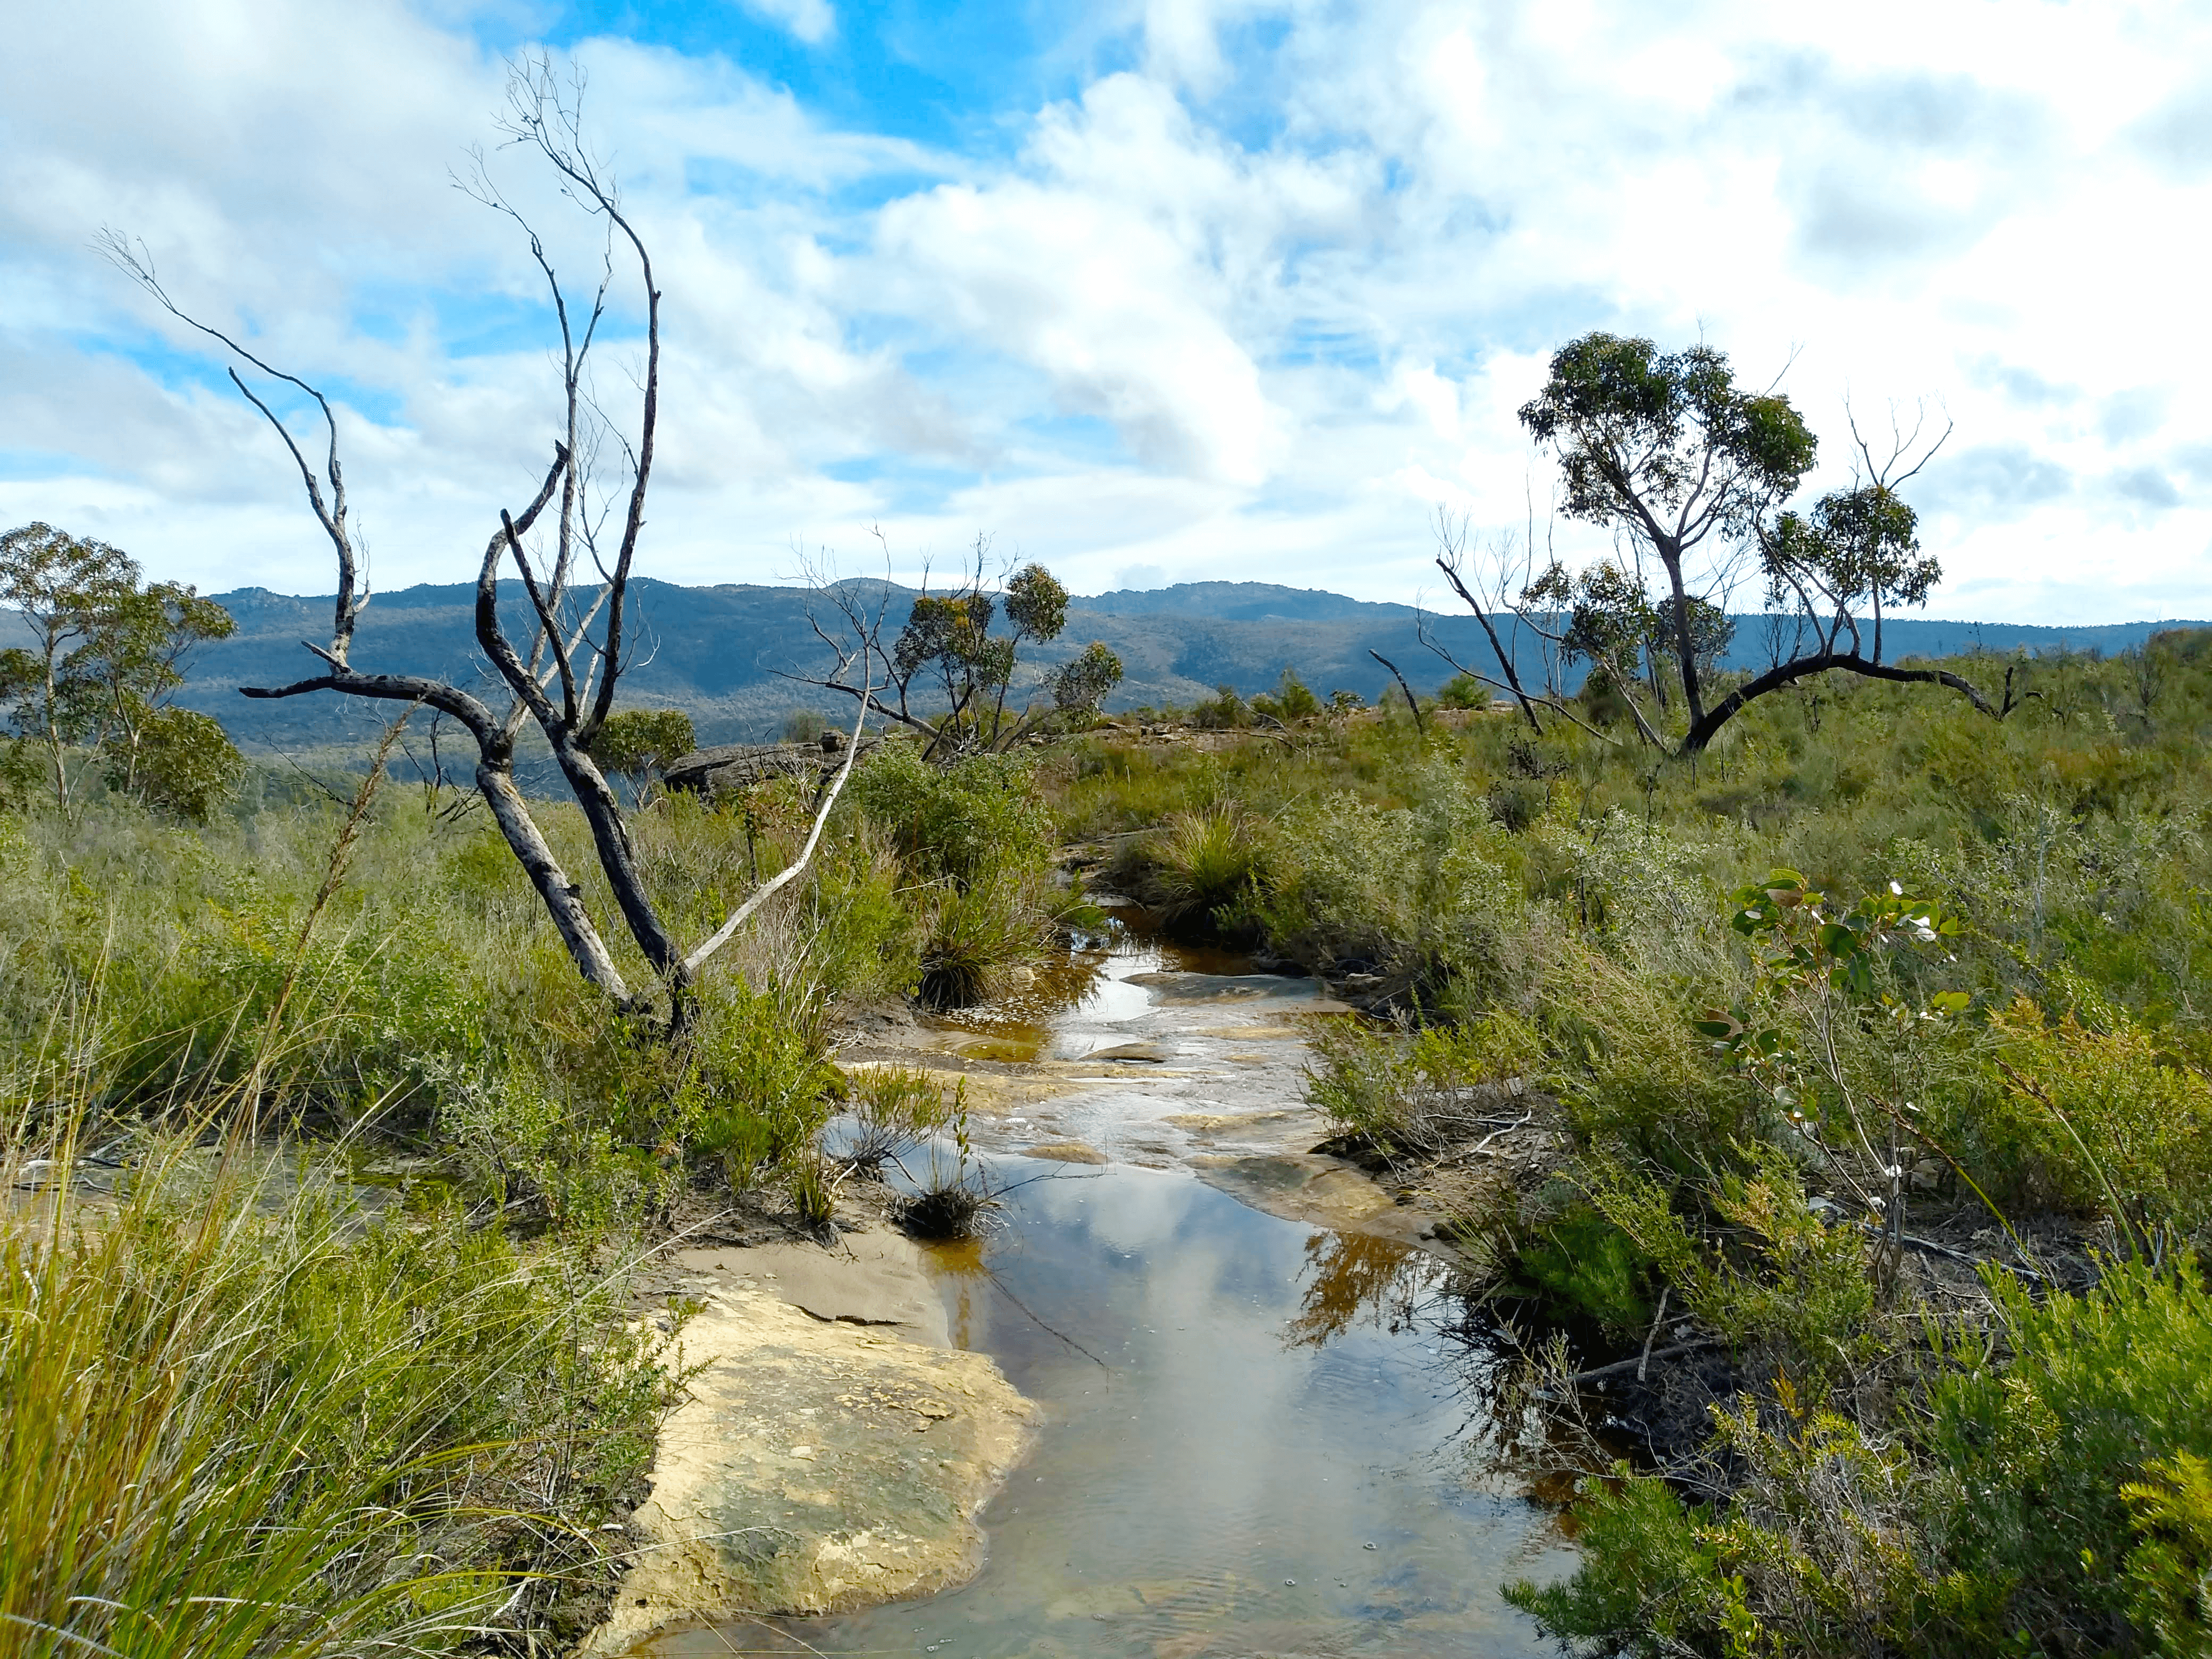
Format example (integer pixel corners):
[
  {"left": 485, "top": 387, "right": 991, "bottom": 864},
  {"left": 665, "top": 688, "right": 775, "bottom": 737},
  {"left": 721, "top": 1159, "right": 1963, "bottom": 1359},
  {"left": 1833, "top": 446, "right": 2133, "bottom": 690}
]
[{"left": 0, "top": 1079, "right": 666, "bottom": 1659}]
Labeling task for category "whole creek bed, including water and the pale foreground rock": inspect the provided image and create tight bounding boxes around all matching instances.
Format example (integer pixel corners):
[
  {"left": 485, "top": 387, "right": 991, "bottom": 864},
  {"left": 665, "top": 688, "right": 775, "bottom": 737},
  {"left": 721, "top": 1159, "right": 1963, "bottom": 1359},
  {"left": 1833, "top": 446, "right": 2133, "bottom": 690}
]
[{"left": 586, "top": 924, "right": 1568, "bottom": 1659}]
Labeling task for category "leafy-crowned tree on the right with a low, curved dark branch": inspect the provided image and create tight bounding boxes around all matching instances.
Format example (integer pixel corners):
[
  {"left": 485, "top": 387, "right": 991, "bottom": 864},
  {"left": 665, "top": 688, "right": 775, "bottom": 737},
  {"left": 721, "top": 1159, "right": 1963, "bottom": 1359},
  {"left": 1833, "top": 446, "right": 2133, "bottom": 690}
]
[{"left": 1429, "top": 334, "right": 1997, "bottom": 755}]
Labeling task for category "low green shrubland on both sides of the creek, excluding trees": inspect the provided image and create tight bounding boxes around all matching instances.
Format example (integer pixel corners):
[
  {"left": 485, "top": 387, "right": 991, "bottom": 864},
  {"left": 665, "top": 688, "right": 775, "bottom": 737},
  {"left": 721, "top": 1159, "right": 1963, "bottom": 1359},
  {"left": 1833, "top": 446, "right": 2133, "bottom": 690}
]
[{"left": 17, "top": 553, "right": 2212, "bottom": 1655}]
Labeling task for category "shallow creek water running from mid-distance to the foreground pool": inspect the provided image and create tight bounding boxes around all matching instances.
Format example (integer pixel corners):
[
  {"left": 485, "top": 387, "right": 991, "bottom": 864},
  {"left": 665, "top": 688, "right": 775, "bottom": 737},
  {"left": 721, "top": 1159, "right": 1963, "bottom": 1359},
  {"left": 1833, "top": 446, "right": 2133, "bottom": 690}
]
[{"left": 641, "top": 936, "right": 1573, "bottom": 1659}]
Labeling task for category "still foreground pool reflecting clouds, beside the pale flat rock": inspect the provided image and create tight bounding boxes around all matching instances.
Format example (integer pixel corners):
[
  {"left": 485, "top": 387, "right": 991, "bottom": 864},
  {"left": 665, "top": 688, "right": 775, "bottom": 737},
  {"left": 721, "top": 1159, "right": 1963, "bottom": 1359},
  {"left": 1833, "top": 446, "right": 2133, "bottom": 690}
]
[{"left": 646, "top": 1159, "right": 1573, "bottom": 1659}]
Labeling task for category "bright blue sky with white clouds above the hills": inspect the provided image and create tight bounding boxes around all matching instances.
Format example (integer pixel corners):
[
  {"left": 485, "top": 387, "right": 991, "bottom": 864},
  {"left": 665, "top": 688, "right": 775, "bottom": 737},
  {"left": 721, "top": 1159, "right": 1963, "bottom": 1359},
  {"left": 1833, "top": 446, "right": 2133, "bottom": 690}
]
[{"left": 0, "top": 0, "right": 2212, "bottom": 624}]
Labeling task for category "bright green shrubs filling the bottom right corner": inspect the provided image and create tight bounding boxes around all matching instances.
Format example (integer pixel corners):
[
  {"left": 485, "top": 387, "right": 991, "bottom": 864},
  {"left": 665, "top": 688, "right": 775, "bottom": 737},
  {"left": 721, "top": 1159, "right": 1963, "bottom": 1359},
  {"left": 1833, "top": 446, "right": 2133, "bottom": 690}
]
[{"left": 1506, "top": 1266, "right": 2212, "bottom": 1659}]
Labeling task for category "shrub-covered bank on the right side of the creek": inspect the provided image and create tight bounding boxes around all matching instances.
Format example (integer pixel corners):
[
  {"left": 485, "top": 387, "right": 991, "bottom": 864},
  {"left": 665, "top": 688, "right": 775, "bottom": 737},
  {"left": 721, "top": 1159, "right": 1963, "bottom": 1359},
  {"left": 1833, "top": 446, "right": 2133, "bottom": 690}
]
[{"left": 1055, "top": 633, "right": 2212, "bottom": 1655}]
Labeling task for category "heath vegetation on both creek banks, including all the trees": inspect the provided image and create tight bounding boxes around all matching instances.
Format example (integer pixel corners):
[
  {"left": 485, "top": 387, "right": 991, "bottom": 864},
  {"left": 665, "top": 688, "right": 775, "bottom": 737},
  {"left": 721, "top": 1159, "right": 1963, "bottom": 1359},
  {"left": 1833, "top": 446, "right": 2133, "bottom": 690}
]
[{"left": 13, "top": 60, "right": 2212, "bottom": 1655}]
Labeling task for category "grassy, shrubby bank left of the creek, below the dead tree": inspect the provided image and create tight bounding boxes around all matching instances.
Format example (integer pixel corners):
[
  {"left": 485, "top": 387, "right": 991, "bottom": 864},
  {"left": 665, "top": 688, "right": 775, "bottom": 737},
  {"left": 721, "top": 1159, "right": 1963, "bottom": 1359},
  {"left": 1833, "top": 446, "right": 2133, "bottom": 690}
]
[{"left": 0, "top": 703, "right": 1088, "bottom": 1655}]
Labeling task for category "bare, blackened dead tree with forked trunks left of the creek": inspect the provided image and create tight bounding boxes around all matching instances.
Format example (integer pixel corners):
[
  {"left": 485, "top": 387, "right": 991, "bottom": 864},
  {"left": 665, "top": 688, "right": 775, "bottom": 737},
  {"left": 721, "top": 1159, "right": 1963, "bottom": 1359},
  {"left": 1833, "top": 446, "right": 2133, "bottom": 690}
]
[{"left": 102, "top": 57, "right": 852, "bottom": 1028}]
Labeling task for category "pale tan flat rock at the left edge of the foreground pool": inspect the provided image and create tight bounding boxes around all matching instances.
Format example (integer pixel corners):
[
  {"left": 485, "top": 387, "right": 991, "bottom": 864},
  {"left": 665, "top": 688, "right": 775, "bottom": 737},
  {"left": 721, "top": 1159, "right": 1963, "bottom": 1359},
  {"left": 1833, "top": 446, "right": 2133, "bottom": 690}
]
[{"left": 577, "top": 1234, "right": 1037, "bottom": 1659}]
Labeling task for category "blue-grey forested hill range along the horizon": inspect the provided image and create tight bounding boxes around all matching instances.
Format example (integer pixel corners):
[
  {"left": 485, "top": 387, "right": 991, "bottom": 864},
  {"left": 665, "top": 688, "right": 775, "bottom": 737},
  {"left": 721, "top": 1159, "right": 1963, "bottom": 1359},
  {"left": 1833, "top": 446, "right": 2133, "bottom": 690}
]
[{"left": 0, "top": 580, "right": 2208, "bottom": 752}]
